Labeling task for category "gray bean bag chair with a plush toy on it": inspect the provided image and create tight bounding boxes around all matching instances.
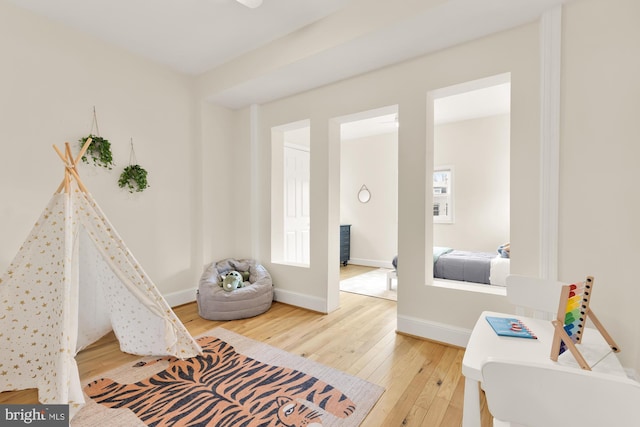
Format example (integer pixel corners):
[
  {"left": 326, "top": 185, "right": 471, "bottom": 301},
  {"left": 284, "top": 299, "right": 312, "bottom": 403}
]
[{"left": 196, "top": 258, "right": 273, "bottom": 320}]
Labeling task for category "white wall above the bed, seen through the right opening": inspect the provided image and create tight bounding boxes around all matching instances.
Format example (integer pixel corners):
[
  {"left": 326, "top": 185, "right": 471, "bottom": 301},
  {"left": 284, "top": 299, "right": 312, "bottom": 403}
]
[{"left": 433, "top": 114, "right": 510, "bottom": 252}]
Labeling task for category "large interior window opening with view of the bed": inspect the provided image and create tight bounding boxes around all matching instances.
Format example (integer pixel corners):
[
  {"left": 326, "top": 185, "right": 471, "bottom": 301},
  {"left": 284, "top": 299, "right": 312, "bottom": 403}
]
[{"left": 426, "top": 73, "right": 511, "bottom": 295}]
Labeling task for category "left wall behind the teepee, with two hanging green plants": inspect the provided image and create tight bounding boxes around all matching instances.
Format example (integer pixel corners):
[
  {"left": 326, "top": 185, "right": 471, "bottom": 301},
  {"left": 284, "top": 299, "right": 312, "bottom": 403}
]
[{"left": 0, "top": 1, "right": 200, "bottom": 304}]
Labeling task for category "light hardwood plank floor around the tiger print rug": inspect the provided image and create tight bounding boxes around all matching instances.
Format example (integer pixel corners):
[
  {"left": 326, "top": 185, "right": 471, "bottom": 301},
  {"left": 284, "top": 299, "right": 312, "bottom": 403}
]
[{"left": 0, "top": 266, "right": 492, "bottom": 427}]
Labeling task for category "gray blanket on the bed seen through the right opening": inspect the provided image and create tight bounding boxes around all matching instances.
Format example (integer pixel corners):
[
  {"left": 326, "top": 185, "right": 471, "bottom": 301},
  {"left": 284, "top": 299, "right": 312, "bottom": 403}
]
[{"left": 433, "top": 251, "right": 496, "bottom": 285}]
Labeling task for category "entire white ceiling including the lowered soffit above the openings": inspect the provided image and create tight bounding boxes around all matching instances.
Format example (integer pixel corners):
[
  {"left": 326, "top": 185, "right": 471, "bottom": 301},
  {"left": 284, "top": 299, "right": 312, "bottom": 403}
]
[{"left": 8, "top": 0, "right": 577, "bottom": 109}]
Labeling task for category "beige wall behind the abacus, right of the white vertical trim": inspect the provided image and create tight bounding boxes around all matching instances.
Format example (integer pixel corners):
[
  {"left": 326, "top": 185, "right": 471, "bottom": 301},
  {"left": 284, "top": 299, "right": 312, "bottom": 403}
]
[{"left": 559, "top": 0, "right": 640, "bottom": 370}]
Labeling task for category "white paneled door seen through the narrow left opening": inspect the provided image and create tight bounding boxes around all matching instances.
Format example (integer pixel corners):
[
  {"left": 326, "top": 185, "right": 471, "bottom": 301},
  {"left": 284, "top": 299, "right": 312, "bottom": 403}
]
[{"left": 284, "top": 145, "right": 310, "bottom": 265}]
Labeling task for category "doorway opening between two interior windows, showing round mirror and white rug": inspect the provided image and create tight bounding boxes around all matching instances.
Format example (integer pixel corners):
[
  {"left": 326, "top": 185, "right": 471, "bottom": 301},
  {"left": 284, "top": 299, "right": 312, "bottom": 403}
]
[{"left": 336, "top": 105, "right": 399, "bottom": 300}]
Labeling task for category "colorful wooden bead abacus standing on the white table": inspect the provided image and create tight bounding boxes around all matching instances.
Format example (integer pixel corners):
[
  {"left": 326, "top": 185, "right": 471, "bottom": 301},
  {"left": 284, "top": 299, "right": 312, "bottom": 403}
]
[{"left": 551, "top": 276, "right": 620, "bottom": 371}]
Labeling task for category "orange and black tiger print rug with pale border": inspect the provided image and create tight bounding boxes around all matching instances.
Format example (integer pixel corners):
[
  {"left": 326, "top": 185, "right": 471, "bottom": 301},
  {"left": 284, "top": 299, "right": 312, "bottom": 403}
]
[{"left": 71, "top": 328, "right": 384, "bottom": 427}]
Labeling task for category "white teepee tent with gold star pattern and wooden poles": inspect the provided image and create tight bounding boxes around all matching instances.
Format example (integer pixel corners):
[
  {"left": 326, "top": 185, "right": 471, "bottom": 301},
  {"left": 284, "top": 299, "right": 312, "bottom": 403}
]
[{"left": 0, "top": 140, "right": 201, "bottom": 416}]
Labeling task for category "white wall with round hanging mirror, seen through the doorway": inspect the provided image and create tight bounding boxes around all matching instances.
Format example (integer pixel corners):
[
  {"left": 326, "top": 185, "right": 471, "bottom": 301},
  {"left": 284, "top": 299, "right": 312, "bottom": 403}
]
[{"left": 340, "top": 132, "right": 398, "bottom": 267}]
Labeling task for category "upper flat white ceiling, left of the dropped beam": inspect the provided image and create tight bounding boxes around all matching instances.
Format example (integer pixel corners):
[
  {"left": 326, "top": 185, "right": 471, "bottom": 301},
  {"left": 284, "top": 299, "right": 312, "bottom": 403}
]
[{"left": 7, "top": 0, "right": 350, "bottom": 75}]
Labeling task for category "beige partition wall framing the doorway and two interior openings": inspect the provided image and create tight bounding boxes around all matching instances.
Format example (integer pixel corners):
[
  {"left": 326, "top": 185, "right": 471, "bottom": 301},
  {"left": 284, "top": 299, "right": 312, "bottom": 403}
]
[{"left": 246, "top": 20, "right": 539, "bottom": 333}]
